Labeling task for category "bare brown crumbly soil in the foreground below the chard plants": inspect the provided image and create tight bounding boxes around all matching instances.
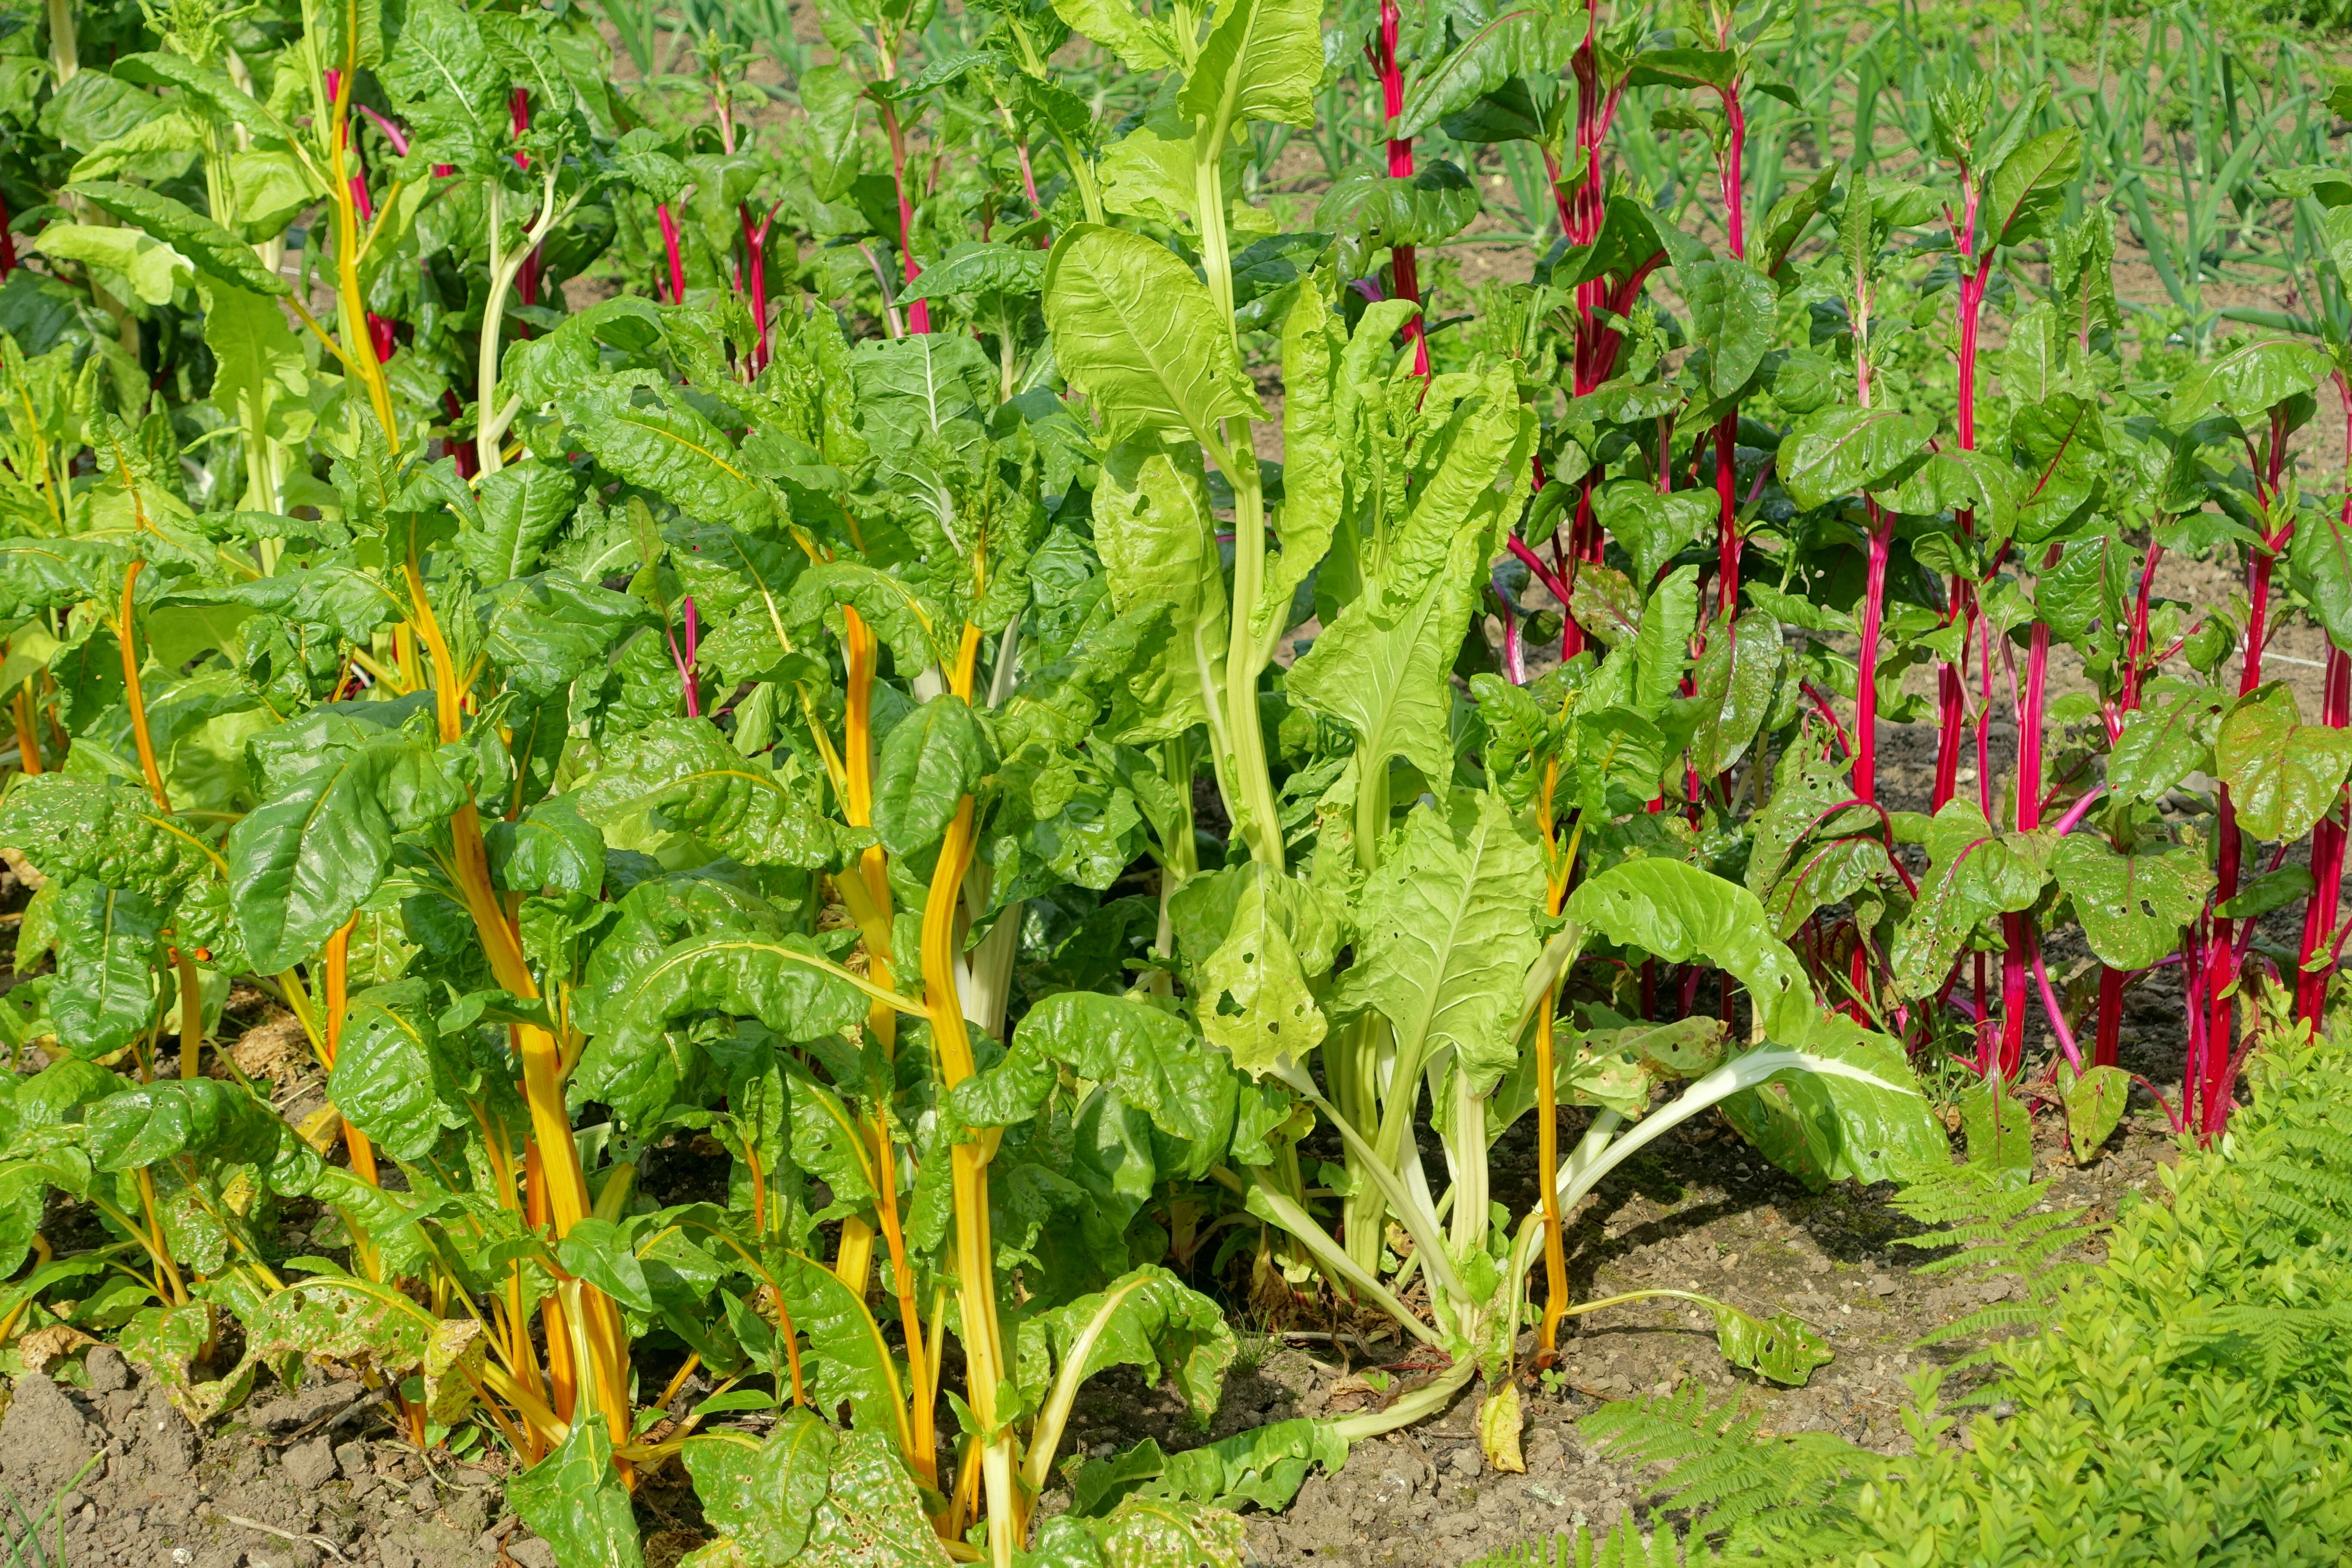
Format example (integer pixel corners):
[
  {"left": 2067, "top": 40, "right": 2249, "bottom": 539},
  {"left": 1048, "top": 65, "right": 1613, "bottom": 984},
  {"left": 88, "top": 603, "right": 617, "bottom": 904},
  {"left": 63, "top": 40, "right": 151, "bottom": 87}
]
[{"left": 0, "top": 1081, "right": 2173, "bottom": 1568}]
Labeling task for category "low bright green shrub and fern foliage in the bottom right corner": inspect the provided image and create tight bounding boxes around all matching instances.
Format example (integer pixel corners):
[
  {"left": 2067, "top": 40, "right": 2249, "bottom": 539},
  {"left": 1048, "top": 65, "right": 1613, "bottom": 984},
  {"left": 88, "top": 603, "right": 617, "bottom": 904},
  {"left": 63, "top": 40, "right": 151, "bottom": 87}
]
[{"left": 1479, "top": 1034, "right": 2352, "bottom": 1568}]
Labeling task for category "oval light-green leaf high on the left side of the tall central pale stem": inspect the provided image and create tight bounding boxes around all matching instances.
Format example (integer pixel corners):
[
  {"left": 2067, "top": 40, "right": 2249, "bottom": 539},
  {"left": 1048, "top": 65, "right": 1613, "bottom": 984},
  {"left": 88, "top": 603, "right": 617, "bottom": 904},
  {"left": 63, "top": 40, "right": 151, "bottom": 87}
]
[{"left": 1044, "top": 223, "right": 1265, "bottom": 444}]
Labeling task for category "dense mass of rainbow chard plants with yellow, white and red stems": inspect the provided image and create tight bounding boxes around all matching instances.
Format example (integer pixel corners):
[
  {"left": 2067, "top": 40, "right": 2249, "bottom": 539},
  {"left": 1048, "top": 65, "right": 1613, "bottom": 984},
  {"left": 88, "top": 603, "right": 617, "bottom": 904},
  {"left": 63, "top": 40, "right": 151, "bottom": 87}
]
[{"left": 0, "top": 0, "right": 2352, "bottom": 1568}]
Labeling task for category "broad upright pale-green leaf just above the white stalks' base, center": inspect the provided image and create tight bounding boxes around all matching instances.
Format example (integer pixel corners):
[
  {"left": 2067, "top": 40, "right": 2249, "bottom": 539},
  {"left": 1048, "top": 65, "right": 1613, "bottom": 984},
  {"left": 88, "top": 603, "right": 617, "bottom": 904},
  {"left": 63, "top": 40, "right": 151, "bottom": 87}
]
[{"left": 1338, "top": 790, "right": 1543, "bottom": 1093}]
